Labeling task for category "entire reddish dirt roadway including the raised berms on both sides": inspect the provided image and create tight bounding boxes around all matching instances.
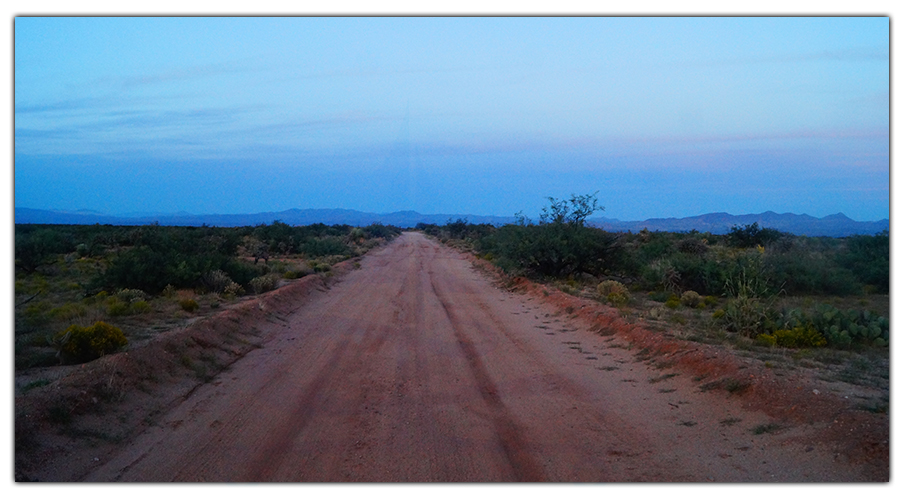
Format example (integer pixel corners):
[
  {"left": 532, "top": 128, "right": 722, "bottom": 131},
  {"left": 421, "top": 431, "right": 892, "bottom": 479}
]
[{"left": 16, "top": 233, "right": 888, "bottom": 482}]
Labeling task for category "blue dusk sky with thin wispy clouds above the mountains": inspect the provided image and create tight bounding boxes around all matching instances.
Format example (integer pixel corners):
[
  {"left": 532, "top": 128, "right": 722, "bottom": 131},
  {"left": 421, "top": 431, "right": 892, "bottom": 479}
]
[{"left": 14, "top": 17, "right": 890, "bottom": 220}]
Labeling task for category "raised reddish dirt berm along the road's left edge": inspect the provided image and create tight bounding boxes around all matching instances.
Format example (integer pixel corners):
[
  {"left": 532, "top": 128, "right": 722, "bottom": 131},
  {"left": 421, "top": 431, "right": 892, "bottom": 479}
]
[{"left": 15, "top": 259, "right": 359, "bottom": 481}]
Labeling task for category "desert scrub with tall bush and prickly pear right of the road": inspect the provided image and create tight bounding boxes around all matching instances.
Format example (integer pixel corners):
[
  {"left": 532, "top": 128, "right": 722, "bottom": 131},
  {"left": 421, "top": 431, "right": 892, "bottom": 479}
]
[{"left": 418, "top": 194, "right": 890, "bottom": 408}]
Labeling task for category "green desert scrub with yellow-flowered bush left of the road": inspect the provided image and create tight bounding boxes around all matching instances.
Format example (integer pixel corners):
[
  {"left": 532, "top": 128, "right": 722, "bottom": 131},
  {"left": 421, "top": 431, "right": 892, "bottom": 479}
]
[{"left": 15, "top": 221, "right": 400, "bottom": 370}]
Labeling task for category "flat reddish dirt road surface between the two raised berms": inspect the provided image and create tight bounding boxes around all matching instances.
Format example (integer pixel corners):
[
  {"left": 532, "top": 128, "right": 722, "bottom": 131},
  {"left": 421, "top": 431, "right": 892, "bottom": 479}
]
[{"left": 84, "top": 233, "right": 880, "bottom": 482}]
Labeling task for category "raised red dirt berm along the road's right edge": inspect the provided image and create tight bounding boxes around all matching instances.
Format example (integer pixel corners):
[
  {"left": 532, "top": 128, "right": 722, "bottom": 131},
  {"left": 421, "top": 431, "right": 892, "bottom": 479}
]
[{"left": 466, "top": 255, "right": 890, "bottom": 481}]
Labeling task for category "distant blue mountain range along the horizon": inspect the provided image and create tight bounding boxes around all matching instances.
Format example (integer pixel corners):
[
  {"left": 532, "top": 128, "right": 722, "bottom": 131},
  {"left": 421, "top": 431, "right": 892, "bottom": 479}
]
[{"left": 15, "top": 208, "right": 890, "bottom": 237}]
